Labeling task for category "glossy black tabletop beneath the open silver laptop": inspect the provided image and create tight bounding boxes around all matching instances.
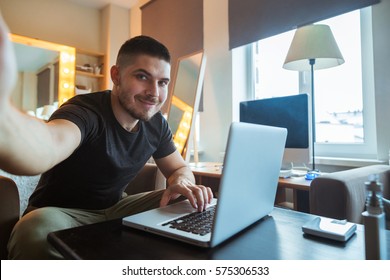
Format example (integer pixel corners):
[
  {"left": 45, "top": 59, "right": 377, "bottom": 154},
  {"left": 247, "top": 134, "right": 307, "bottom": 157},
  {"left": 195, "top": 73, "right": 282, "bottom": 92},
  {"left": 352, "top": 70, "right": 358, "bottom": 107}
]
[{"left": 48, "top": 208, "right": 390, "bottom": 260}]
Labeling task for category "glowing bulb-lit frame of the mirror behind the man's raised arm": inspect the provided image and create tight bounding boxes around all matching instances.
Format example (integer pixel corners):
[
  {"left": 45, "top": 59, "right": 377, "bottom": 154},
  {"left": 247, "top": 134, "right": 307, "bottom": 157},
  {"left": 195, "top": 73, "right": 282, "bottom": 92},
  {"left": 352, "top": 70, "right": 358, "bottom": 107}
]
[{"left": 10, "top": 34, "right": 76, "bottom": 110}]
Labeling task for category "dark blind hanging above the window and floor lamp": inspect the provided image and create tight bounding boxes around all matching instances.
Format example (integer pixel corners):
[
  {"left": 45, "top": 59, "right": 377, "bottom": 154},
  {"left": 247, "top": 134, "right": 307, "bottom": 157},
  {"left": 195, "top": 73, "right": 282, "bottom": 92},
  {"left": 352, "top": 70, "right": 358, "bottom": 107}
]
[{"left": 229, "top": 0, "right": 380, "bottom": 49}]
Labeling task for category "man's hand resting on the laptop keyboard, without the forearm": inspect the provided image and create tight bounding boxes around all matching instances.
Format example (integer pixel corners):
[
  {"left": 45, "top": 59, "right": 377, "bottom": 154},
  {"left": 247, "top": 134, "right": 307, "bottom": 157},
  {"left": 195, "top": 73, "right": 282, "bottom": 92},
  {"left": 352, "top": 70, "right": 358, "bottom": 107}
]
[{"left": 160, "top": 180, "right": 213, "bottom": 212}]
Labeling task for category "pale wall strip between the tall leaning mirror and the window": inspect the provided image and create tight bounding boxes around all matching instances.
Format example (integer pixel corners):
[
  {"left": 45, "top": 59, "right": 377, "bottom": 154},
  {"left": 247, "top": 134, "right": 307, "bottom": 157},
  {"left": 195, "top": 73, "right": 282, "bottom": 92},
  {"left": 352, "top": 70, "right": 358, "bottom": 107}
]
[{"left": 199, "top": 0, "right": 233, "bottom": 161}]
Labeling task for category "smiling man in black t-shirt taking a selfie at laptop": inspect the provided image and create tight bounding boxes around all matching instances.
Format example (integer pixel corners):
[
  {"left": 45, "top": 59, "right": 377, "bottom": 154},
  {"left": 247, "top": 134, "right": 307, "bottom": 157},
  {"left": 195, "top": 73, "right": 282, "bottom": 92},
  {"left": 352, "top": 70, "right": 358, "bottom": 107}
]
[{"left": 0, "top": 12, "right": 213, "bottom": 259}]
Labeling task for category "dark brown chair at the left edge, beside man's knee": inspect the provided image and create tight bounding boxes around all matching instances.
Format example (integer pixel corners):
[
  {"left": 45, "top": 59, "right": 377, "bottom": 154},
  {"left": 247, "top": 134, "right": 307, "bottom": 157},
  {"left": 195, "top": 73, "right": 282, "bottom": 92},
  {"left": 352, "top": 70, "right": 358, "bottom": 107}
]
[{"left": 0, "top": 176, "right": 20, "bottom": 260}]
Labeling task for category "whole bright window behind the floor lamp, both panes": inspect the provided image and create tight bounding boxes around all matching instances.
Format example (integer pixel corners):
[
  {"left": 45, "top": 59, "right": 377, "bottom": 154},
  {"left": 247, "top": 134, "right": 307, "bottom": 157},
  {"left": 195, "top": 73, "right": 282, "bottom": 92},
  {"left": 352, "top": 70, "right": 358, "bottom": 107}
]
[{"left": 253, "top": 8, "right": 375, "bottom": 158}]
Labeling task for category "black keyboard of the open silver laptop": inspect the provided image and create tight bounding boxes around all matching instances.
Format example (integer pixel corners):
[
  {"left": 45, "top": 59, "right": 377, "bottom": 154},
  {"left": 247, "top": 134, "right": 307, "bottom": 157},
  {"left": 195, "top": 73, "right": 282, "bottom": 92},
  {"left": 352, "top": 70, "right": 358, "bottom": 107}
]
[{"left": 163, "top": 205, "right": 215, "bottom": 235}]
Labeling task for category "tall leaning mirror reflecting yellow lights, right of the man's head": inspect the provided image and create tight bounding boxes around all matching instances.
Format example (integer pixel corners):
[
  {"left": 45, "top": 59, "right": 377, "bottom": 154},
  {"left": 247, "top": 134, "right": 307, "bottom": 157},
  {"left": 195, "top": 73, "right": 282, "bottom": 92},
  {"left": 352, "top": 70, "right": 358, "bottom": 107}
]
[{"left": 168, "top": 51, "right": 206, "bottom": 162}]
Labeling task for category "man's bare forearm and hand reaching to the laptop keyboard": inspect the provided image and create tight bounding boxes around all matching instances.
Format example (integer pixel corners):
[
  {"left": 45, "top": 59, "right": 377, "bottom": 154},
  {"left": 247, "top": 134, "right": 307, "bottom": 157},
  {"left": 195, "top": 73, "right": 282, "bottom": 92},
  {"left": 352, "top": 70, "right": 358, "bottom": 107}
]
[{"left": 156, "top": 151, "right": 213, "bottom": 211}]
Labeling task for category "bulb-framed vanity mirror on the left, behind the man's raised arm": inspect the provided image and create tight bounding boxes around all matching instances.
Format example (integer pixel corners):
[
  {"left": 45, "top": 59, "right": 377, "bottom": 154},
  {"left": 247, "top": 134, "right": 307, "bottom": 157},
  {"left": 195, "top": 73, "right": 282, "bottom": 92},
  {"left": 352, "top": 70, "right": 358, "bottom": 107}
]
[{"left": 10, "top": 34, "right": 75, "bottom": 119}]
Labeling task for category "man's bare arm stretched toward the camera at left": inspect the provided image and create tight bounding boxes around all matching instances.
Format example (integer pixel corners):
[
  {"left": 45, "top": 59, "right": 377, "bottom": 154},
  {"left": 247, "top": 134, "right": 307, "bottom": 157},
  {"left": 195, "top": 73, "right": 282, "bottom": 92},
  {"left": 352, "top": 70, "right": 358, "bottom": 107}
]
[{"left": 0, "top": 14, "right": 81, "bottom": 175}]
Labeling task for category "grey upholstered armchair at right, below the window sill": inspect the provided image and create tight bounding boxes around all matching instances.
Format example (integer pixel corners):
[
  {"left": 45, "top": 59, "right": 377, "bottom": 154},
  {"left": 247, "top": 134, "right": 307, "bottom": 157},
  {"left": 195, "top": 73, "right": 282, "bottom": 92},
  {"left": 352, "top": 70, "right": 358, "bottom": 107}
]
[{"left": 310, "top": 165, "right": 390, "bottom": 224}]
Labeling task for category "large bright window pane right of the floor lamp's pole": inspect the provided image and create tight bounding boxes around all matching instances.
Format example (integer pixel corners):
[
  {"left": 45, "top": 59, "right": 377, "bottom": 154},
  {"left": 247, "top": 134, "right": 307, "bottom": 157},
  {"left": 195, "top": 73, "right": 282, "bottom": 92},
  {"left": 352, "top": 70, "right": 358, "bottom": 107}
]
[{"left": 314, "top": 11, "right": 364, "bottom": 144}]
